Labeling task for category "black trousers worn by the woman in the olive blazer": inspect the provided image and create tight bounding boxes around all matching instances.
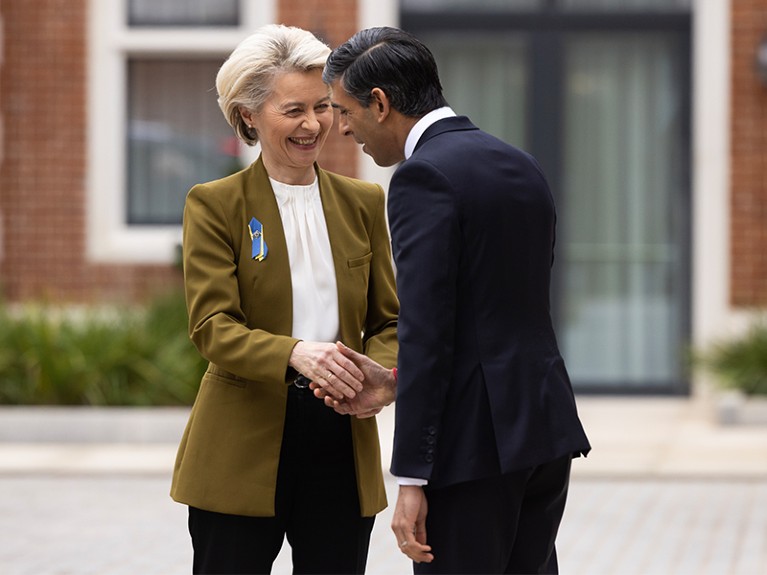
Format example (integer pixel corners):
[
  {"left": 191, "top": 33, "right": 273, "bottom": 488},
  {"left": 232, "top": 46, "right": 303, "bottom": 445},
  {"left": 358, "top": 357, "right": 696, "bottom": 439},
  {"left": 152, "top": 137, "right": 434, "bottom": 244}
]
[{"left": 189, "top": 386, "right": 375, "bottom": 574}]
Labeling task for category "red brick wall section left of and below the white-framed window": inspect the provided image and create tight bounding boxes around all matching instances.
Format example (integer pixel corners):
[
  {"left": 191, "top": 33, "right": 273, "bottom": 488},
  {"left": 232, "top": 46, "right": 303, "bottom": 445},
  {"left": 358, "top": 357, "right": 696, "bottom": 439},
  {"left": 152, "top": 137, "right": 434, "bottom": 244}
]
[{"left": 0, "top": 0, "right": 180, "bottom": 302}]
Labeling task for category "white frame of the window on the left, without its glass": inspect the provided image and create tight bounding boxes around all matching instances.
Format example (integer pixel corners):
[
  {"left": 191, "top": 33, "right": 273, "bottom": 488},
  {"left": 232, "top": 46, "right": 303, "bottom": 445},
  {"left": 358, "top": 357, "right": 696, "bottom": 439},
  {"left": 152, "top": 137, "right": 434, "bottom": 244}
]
[{"left": 86, "top": 0, "right": 277, "bottom": 264}]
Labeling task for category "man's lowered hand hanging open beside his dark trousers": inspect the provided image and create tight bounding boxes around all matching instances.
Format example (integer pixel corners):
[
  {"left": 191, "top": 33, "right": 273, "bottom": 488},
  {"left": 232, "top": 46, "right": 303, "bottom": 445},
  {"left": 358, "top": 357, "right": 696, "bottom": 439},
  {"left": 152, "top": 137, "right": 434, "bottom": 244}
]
[{"left": 391, "top": 485, "right": 434, "bottom": 563}]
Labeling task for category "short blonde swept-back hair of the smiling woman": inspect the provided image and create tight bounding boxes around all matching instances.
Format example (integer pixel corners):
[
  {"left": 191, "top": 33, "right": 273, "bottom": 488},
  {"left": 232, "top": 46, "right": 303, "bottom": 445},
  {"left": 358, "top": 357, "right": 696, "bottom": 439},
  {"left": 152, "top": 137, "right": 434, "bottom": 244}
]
[{"left": 216, "top": 24, "right": 330, "bottom": 146}]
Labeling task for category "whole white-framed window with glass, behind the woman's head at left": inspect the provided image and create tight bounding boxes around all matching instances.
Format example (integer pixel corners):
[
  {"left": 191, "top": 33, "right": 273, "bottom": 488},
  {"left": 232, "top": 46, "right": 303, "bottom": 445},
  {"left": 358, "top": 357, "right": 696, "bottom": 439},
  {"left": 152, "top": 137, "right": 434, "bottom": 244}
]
[{"left": 87, "top": 0, "right": 276, "bottom": 263}]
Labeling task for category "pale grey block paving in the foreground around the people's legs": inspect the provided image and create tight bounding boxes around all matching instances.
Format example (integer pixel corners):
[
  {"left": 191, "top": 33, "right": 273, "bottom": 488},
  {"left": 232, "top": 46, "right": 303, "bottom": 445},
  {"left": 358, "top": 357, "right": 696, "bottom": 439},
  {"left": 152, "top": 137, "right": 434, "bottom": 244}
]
[{"left": 0, "top": 475, "right": 767, "bottom": 575}]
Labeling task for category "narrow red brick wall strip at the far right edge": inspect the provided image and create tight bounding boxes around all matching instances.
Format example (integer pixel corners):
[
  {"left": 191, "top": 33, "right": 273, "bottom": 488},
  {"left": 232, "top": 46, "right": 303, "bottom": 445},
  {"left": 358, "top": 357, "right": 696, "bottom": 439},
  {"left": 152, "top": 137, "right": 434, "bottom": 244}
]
[{"left": 730, "top": 0, "right": 767, "bottom": 307}]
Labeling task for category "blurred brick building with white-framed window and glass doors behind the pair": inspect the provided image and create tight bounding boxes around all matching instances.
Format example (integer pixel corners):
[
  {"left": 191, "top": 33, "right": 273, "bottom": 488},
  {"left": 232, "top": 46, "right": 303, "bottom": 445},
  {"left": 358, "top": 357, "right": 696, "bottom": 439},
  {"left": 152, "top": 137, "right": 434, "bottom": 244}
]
[{"left": 0, "top": 0, "right": 767, "bottom": 394}]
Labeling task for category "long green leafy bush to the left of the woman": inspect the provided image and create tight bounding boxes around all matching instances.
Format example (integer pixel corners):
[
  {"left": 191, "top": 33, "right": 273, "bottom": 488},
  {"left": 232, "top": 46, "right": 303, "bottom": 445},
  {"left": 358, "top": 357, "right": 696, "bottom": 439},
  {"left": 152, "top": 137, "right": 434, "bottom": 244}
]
[{"left": 0, "top": 293, "right": 206, "bottom": 406}]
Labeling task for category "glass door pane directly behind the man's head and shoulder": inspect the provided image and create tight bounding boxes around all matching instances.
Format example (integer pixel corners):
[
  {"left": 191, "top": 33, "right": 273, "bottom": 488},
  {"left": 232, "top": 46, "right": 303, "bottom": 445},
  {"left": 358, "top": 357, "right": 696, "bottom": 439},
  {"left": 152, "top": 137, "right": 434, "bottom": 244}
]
[{"left": 419, "top": 32, "right": 527, "bottom": 148}]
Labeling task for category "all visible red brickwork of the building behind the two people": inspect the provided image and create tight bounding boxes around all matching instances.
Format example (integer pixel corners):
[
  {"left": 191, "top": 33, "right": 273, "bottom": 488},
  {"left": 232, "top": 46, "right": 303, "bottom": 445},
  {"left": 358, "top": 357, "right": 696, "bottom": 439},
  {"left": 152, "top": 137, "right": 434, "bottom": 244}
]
[{"left": 0, "top": 0, "right": 767, "bottom": 307}]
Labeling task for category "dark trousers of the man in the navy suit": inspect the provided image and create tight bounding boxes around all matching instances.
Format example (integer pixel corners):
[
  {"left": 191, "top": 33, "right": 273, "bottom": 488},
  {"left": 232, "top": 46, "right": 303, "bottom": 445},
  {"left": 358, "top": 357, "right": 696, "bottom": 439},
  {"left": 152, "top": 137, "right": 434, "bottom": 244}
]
[{"left": 413, "top": 455, "right": 572, "bottom": 575}]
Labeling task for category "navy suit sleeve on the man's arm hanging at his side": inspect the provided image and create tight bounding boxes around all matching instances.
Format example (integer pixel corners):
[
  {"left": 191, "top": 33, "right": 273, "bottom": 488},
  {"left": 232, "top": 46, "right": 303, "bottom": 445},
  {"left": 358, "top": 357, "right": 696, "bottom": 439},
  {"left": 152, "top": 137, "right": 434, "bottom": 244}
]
[{"left": 389, "top": 159, "right": 462, "bottom": 479}]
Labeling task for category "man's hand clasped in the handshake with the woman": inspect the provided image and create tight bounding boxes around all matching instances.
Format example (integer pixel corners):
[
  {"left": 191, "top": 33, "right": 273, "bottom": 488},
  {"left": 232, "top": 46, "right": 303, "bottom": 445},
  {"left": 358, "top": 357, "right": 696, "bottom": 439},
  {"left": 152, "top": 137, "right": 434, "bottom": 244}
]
[{"left": 312, "top": 342, "right": 397, "bottom": 418}]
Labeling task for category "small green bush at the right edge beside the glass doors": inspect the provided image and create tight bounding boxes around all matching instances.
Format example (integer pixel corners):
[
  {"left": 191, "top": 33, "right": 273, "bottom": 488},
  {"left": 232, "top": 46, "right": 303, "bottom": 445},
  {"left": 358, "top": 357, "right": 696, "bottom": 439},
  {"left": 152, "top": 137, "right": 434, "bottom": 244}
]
[{"left": 696, "top": 321, "right": 767, "bottom": 395}]
